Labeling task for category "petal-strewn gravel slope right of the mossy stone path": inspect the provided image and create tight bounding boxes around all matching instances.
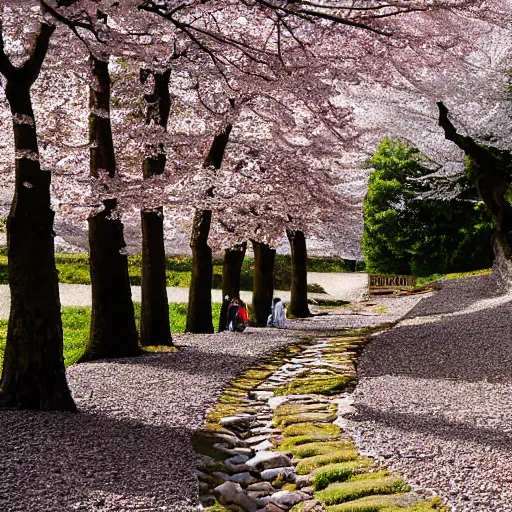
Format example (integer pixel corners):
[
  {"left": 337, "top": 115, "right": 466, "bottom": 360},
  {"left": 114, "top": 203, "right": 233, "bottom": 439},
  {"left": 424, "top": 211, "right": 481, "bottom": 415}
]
[{"left": 349, "top": 276, "right": 512, "bottom": 512}]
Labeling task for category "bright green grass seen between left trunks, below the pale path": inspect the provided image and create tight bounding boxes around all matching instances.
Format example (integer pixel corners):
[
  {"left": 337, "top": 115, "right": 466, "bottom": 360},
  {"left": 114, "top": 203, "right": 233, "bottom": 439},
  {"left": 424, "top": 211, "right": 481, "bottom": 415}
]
[{"left": 0, "top": 302, "right": 221, "bottom": 368}]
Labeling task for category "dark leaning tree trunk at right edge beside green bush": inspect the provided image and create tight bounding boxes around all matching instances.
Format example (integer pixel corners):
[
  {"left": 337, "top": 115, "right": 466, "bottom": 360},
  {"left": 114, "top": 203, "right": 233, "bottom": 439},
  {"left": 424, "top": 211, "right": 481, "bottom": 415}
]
[{"left": 437, "top": 102, "right": 512, "bottom": 287}]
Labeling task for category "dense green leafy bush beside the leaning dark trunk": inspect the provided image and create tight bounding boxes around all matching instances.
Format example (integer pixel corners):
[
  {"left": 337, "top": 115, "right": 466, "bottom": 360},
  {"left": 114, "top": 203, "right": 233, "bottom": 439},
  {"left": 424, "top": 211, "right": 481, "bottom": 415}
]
[{"left": 362, "top": 139, "right": 494, "bottom": 276}]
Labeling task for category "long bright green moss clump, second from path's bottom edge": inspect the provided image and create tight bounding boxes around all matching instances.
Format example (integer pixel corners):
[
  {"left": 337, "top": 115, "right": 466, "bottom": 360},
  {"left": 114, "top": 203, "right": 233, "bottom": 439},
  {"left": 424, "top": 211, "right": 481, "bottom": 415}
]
[{"left": 315, "top": 471, "right": 410, "bottom": 505}]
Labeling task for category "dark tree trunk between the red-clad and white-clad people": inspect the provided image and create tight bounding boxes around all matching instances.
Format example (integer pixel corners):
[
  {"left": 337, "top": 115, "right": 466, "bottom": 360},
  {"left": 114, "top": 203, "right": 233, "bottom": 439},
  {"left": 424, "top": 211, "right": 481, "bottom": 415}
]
[{"left": 252, "top": 240, "right": 276, "bottom": 327}]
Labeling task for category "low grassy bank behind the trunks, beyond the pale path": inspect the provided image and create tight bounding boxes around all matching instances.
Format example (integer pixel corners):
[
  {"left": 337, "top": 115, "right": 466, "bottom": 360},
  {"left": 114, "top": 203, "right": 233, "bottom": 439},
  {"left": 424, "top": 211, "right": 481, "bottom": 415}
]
[{"left": 0, "top": 251, "right": 347, "bottom": 291}]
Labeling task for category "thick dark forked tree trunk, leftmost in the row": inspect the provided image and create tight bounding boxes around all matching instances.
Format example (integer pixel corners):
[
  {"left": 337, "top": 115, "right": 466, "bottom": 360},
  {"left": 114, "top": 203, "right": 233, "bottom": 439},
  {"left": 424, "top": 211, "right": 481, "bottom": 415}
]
[{"left": 0, "top": 25, "right": 76, "bottom": 411}]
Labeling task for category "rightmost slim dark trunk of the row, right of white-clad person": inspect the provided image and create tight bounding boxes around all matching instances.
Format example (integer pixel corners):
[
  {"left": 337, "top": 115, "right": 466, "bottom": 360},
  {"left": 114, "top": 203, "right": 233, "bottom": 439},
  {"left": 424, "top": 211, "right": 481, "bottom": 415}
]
[{"left": 286, "top": 229, "right": 311, "bottom": 318}]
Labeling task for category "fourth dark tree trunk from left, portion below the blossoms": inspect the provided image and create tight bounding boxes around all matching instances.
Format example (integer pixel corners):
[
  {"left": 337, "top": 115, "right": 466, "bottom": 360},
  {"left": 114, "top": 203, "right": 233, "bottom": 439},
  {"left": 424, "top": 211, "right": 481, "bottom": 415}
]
[{"left": 185, "top": 210, "right": 213, "bottom": 334}]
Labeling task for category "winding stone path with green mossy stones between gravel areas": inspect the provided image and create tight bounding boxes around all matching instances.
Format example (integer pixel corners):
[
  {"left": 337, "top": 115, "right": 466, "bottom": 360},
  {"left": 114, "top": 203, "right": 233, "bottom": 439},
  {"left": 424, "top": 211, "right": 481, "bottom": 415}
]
[{"left": 196, "top": 334, "right": 441, "bottom": 512}]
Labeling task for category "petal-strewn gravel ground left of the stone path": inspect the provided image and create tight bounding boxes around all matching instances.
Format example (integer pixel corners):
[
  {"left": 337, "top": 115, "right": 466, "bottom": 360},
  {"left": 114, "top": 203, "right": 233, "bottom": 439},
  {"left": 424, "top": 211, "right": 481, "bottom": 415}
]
[{"left": 0, "top": 297, "right": 419, "bottom": 512}]
